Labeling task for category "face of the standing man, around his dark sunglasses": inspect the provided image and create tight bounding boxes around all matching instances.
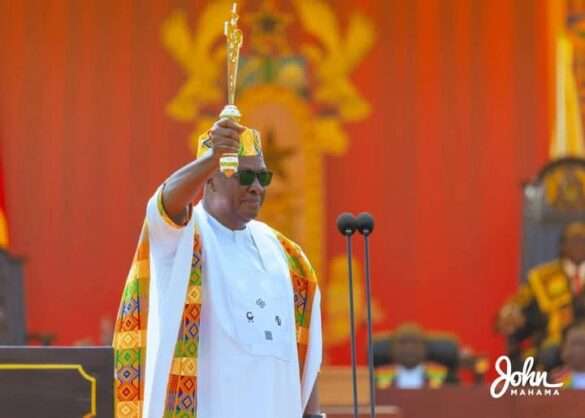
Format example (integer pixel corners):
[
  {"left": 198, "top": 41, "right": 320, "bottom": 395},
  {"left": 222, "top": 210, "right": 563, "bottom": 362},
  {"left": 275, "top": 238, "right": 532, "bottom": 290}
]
[{"left": 214, "top": 156, "right": 267, "bottom": 222}]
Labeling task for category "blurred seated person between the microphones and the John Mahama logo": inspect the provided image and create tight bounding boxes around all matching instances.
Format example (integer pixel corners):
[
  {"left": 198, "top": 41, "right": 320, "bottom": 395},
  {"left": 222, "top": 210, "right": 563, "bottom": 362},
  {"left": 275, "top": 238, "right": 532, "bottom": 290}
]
[{"left": 376, "top": 324, "right": 447, "bottom": 389}]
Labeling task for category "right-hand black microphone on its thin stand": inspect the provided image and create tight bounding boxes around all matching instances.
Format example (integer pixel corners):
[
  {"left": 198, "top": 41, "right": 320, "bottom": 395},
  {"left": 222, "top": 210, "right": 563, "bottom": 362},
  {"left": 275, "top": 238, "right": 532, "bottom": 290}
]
[{"left": 355, "top": 212, "right": 376, "bottom": 418}]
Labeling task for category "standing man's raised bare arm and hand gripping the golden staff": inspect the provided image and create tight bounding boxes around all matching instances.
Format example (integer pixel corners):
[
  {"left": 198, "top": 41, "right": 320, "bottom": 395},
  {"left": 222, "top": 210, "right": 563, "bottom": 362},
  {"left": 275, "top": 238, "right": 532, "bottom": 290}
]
[{"left": 162, "top": 119, "right": 244, "bottom": 225}]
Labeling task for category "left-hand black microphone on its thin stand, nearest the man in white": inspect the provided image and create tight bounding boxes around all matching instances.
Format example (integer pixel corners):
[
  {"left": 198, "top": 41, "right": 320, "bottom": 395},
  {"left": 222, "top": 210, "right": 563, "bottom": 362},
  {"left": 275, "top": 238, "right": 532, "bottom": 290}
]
[{"left": 337, "top": 212, "right": 358, "bottom": 418}]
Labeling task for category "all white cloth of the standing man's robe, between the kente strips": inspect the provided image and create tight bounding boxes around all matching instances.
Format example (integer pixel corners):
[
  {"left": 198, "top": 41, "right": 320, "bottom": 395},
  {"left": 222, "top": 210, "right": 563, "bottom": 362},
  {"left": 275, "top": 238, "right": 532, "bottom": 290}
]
[{"left": 143, "top": 188, "right": 322, "bottom": 418}]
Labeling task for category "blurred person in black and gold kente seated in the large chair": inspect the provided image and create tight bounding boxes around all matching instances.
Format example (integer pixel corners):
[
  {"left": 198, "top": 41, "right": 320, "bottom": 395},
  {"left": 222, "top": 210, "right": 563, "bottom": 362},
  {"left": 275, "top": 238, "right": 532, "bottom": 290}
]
[{"left": 496, "top": 222, "right": 585, "bottom": 368}]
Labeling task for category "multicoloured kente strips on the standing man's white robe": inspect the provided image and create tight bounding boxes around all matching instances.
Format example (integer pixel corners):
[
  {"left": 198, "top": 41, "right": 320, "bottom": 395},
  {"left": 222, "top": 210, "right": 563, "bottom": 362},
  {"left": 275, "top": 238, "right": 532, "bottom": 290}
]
[{"left": 113, "top": 222, "right": 317, "bottom": 418}]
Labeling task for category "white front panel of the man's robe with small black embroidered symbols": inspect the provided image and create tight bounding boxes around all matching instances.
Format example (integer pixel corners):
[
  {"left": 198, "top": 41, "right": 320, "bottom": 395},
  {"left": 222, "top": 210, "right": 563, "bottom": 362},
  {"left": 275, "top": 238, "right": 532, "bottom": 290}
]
[{"left": 195, "top": 206, "right": 302, "bottom": 418}]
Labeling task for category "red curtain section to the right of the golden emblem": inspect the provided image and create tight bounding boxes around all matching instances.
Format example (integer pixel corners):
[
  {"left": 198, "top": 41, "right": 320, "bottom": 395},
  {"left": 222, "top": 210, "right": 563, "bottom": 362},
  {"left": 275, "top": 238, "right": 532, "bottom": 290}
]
[{"left": 327, "top": 0, "right": 550, "bottom": 361}]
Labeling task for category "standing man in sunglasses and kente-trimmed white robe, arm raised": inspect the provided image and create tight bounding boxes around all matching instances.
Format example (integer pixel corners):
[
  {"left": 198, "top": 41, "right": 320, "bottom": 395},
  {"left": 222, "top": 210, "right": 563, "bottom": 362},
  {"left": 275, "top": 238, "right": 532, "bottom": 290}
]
[{"left": 114, "top": 119, "right": 322, "bottom": 418}]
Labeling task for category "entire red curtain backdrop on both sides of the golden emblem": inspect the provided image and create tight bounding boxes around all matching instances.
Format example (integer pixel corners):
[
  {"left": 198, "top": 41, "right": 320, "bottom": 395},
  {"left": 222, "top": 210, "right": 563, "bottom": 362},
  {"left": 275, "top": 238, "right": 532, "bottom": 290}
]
[{"left": 0, "top": 0, "right": 552, "bottom": 362}]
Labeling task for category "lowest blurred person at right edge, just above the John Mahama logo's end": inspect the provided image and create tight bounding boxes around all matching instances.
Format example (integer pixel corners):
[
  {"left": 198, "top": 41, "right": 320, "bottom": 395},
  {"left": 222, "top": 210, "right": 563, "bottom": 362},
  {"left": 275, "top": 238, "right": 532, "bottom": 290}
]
[{"left": 553, "top": 322, "right": 585, "bottom": 390}]
